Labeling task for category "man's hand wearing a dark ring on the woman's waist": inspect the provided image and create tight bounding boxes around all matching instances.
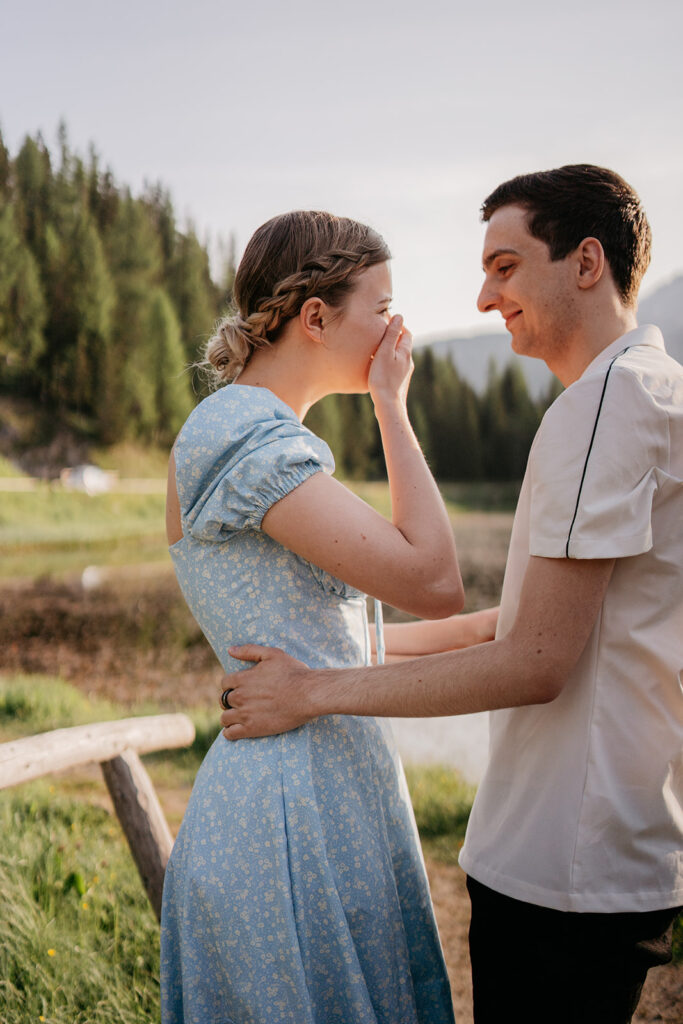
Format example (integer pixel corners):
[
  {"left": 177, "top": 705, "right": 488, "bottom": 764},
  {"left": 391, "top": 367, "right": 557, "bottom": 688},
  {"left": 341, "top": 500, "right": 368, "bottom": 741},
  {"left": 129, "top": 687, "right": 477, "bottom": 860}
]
[{"left": 220, "top": 644, "right": 316, "bottom": 739}]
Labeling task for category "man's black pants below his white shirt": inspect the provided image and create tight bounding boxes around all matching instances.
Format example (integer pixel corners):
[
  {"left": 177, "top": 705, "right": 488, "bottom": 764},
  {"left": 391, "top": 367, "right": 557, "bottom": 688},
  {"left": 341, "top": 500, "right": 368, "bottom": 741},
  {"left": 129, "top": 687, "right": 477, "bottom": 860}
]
[{"left": 467, "top": 878, "right": 680, "bottom": 1024}]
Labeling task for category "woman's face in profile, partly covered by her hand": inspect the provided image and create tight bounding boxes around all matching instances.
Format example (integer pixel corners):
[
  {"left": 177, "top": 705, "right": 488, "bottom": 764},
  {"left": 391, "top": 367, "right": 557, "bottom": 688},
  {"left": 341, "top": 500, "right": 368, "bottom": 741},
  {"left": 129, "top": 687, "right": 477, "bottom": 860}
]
[{"left": 324, "top": 262, "right": 391, "bottom": 393}]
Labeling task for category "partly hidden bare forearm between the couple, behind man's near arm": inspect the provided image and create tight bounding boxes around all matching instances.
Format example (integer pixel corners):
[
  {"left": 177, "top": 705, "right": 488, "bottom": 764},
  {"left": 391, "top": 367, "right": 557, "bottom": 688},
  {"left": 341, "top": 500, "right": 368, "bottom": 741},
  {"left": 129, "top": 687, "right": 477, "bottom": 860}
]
[{"left": 370, "top": 607, "right": 499, "bottom": 657}]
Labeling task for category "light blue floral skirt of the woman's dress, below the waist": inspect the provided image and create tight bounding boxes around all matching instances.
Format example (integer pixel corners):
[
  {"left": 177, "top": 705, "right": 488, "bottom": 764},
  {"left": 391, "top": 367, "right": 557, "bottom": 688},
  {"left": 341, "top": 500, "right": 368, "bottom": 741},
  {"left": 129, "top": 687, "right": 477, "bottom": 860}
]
[{"left": 162, "top": 716, "right": 453, "bottom": 1024}]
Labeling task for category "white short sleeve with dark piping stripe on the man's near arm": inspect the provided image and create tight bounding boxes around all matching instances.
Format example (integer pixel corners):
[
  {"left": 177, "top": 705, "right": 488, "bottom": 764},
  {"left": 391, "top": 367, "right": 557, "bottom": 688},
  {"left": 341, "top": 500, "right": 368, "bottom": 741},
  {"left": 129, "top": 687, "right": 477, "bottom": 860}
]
[{"left": 528, "top": 362, "right": 669, "bottom": 558}]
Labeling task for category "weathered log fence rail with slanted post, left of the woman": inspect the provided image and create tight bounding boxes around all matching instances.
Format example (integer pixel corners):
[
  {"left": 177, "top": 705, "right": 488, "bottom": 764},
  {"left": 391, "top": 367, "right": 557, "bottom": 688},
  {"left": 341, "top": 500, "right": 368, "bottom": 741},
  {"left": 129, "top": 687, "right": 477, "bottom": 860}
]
[{"left": 0, "top": 715, "right": 195, "bottom": 919}]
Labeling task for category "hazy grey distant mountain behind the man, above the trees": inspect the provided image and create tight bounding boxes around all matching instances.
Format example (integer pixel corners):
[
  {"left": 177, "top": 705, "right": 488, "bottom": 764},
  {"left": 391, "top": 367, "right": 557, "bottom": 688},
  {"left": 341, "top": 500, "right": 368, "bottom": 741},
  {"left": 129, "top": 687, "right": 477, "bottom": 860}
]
[{"left": 418, "top": 273, "right": 683, "bottom": 398}]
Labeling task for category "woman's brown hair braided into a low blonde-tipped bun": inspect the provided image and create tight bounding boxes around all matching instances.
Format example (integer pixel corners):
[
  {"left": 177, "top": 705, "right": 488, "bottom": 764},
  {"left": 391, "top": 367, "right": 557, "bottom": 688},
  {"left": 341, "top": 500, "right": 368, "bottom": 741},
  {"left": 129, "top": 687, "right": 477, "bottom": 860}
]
[{"left": 204, "top": 210, "right": 391, "bottom": 384}]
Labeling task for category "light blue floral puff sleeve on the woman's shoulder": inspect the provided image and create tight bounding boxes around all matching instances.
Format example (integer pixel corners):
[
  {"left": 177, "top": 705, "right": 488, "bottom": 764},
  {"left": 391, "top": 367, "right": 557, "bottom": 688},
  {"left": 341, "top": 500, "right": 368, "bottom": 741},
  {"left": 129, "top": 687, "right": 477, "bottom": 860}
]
[{"left": 175, "top": 388, "right": 334, "bottom": 542}]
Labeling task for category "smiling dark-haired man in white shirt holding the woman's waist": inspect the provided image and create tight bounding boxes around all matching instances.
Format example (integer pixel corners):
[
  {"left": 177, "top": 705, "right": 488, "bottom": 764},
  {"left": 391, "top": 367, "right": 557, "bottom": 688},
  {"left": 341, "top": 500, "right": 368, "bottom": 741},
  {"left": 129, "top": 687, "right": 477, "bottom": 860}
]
[{"left": 221, "top": 165, "right": 683, "bottom": 1024}]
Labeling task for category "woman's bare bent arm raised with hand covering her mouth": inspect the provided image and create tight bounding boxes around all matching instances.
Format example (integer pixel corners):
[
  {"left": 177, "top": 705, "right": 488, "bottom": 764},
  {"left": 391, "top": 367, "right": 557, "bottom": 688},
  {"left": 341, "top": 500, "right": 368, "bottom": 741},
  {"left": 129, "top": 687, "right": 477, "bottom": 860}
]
[{"left": 262, "top": 317, "right": 463, "bottom": 618}]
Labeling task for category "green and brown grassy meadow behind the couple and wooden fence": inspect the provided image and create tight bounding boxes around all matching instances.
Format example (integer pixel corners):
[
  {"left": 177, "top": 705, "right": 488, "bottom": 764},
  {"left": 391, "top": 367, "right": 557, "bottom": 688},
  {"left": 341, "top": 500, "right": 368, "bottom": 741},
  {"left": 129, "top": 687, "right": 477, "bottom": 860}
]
[{"left": 0, "top": 468, "right": 683, "bottom": 1024}]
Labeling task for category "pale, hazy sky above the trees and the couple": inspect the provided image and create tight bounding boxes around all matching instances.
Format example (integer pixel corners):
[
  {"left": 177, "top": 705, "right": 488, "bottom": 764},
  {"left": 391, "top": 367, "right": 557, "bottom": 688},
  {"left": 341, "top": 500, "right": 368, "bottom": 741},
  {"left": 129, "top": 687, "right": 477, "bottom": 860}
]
[{"left": 0, "top": 0, "right": 683, "bottom": 338}]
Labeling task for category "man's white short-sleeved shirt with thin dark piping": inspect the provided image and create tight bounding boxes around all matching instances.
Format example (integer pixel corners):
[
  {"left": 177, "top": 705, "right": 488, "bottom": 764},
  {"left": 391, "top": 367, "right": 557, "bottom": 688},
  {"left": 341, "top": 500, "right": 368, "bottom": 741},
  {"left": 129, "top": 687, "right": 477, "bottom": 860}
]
[{"left": 460, "top": 326, "right": 683, "bottom": 912}]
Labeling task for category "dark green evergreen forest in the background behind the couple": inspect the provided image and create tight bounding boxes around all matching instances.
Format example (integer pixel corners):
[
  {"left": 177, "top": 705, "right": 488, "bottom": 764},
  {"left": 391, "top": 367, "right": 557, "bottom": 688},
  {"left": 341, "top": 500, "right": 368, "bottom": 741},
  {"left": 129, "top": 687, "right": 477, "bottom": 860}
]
[{"left": 0, "top": 125, "right": 554, "bottom": 480}]
